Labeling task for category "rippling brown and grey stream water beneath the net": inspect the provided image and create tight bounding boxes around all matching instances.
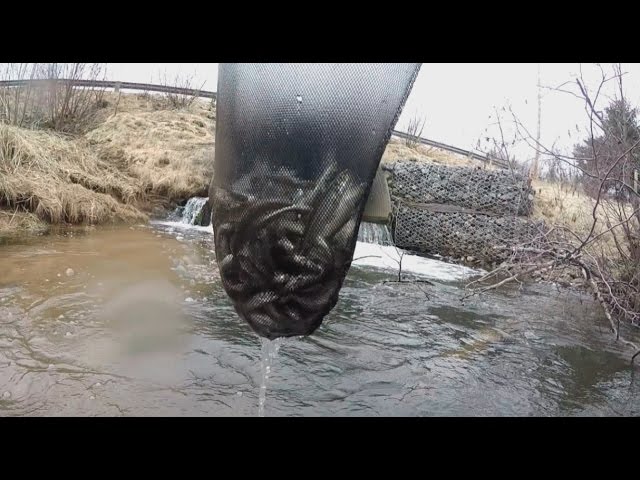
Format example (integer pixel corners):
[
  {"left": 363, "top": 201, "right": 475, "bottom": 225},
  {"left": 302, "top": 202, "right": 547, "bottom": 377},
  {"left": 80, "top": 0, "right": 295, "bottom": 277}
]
[{"left": 0, "top": 225, "right": 640, "bottom": 416}]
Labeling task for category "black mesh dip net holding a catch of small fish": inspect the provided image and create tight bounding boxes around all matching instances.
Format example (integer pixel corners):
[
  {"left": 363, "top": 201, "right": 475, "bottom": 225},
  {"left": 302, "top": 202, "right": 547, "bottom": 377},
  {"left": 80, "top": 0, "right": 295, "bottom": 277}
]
[{"left": 209, "top": 64, "right": 420, "bottom": 339}]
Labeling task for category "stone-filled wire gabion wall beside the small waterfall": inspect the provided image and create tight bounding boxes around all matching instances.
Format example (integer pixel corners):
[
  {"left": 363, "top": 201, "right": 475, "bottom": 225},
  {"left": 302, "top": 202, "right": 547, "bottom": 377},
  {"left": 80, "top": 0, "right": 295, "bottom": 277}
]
[{"left": 389, "top": 162, "right": 544, "bottom": 262}]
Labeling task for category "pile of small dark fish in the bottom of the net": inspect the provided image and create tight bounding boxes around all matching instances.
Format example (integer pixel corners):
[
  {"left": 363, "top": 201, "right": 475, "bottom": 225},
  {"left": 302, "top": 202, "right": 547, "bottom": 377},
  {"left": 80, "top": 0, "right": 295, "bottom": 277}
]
[{"left": 213, "top": 162, "right": 366, "bottom": 339}]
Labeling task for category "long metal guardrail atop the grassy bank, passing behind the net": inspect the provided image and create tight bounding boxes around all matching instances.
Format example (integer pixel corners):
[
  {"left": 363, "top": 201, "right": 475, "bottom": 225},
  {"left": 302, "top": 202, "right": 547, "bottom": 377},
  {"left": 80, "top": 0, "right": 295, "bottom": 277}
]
[{"left": 0, "top": 79, "right": 509, "bottom": 168}]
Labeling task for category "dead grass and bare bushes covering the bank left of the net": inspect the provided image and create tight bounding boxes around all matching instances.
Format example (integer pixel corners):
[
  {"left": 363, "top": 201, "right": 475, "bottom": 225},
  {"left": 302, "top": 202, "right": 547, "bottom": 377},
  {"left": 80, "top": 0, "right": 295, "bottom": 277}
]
[{"left": 0, "top": 64, "right": 215, "bottom": 235}]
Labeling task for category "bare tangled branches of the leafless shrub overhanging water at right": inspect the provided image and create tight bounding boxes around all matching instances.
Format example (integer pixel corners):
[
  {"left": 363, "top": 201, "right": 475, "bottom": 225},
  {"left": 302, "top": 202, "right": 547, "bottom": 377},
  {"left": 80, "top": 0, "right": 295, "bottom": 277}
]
[{"left": 480, "top": 66, "right": 640, "bottom": 363}]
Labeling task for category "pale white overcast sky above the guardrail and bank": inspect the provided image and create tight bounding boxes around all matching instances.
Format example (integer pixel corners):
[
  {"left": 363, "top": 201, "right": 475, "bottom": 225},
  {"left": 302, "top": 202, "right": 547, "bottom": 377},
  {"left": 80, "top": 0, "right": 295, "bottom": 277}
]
[{"left": 107, "top": 63, "right": 640, "bottom": 164}]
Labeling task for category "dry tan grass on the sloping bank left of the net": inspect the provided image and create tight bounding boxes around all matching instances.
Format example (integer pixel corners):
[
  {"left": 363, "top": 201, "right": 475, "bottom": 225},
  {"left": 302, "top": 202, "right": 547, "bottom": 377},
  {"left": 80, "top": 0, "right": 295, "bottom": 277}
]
[{"left": 0, "top": 93, "right": 215, "bottom": 233}]
